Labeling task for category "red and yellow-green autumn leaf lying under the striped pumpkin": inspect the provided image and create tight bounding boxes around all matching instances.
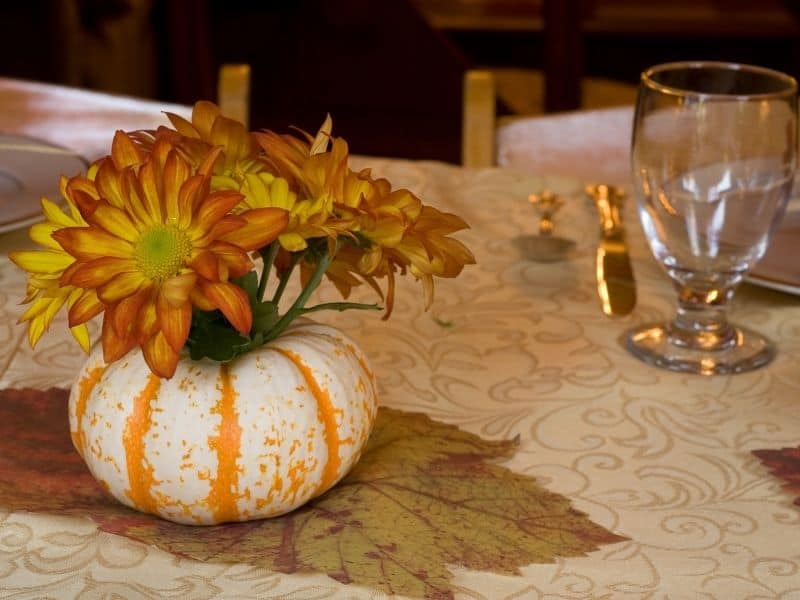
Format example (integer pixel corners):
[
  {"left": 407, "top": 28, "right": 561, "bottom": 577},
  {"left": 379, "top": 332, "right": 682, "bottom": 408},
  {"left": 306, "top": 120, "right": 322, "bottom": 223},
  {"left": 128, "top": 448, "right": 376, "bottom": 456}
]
[{"left": 0, "top": 390, "right": 624, "bottom": 598}]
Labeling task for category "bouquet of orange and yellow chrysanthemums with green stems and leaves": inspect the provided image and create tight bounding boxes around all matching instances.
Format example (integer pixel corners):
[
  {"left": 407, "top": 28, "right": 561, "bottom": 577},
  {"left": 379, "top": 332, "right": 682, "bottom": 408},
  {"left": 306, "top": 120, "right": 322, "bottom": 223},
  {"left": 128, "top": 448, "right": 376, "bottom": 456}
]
[{"left": 11, "top": 102, "right": 475, "bottom": 378}]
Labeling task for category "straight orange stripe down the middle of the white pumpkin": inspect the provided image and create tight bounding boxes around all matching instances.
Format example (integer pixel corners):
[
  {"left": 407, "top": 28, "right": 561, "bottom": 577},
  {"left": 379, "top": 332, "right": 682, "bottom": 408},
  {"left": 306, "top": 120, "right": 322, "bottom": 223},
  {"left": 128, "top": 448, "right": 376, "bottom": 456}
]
[{"left": 206, "top": 365, "right": 242, "bottom": 523}]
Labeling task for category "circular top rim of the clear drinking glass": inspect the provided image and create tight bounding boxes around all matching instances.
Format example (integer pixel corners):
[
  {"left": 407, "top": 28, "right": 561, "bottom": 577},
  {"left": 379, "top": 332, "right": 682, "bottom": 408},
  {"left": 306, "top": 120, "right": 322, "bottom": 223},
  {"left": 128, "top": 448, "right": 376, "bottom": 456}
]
[{"left": 641, "top": 60, "right": 797, "bottom": 100}]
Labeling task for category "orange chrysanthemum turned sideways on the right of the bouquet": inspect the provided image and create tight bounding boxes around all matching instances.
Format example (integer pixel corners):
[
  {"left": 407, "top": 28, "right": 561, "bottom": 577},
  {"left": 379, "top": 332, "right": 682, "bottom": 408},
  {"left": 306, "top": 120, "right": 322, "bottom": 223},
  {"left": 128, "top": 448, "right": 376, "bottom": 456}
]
[{"left": 255, "top": 120, "right": 475, "bottom": 317}]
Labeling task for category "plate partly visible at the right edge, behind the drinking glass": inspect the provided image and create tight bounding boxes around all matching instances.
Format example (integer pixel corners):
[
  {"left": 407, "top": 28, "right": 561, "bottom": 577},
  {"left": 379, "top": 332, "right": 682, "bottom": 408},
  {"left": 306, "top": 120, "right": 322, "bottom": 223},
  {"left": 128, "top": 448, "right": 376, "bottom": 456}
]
[{"left": 746, "top": 209, "right": 800, "bottom": 295}]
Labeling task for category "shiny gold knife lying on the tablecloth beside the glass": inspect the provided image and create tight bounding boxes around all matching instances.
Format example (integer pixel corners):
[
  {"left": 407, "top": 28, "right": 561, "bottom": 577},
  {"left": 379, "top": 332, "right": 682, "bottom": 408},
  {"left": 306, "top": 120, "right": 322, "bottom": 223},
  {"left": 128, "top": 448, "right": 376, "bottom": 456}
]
[{"left": 586, "top": 184, "right": 636, "bottom": 316}]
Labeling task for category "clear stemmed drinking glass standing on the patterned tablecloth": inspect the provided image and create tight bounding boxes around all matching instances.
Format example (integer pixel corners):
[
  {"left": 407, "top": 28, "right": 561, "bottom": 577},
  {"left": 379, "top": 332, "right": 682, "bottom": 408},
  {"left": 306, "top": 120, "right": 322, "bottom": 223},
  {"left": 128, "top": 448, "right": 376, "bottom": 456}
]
[{"left": 626, "top": 62, "right": 797, "bottom": 375}]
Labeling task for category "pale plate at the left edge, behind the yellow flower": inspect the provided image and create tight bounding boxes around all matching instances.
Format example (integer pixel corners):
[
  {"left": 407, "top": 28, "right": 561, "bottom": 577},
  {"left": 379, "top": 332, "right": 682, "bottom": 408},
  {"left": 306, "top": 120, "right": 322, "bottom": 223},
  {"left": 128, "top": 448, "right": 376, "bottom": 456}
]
[{"left": 0, "top": 134, "right": 88, "bottom": 233}]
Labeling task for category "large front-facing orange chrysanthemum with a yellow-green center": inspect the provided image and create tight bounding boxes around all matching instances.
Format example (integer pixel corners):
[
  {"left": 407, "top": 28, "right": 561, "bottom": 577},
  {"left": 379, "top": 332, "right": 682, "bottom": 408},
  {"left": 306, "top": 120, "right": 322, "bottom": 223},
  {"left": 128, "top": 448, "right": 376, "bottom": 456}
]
[{"left": 52, "top": 132, "right": 288, "bottom": 377}]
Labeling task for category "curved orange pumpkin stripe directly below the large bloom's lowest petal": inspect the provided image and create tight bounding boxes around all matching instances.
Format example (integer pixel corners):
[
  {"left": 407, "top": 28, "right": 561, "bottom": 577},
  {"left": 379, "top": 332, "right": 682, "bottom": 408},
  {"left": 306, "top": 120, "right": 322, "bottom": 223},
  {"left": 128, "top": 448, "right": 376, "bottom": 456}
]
[{"left": 122, "top": 373, "right": 161, "bottom": 513}]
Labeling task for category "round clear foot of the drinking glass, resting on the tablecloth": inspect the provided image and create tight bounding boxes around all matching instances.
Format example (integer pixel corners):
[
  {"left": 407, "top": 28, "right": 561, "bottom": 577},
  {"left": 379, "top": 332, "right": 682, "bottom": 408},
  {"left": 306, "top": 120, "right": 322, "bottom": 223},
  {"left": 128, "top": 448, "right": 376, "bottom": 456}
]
[{"left": 623, "top": 323, "right": 775, "bottom": 375}]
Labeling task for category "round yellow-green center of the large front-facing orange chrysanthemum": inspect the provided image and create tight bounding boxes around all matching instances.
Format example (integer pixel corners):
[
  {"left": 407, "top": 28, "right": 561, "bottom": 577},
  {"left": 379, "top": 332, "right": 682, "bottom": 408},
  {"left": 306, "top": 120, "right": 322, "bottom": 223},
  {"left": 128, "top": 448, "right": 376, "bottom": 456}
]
[{"left": 134, "top": 225, "right": 192, "bottom": 281}]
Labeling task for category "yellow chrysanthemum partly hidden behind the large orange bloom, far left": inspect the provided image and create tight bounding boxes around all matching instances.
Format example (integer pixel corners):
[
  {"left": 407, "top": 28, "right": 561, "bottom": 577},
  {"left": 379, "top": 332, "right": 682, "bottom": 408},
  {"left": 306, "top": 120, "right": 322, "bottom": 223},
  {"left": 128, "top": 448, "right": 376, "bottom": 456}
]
[{"left": 9, "top": 177, "right": 102, "bottom": 352}]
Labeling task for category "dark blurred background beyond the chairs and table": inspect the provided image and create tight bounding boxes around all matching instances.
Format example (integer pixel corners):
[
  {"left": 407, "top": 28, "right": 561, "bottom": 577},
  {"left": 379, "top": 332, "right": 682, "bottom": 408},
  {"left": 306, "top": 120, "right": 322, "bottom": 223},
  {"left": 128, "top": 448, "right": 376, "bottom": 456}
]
[{"left": 6, "top": 0, "right": 800, "bottom": 162}]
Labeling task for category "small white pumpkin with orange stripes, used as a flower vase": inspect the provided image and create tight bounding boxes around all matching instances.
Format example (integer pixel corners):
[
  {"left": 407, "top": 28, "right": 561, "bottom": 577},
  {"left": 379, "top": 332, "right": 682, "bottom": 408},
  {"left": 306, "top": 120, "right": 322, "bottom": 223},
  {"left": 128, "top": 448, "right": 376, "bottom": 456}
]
[{"left": 69, "top": 320, "right": 377, "bottom": 525}]
